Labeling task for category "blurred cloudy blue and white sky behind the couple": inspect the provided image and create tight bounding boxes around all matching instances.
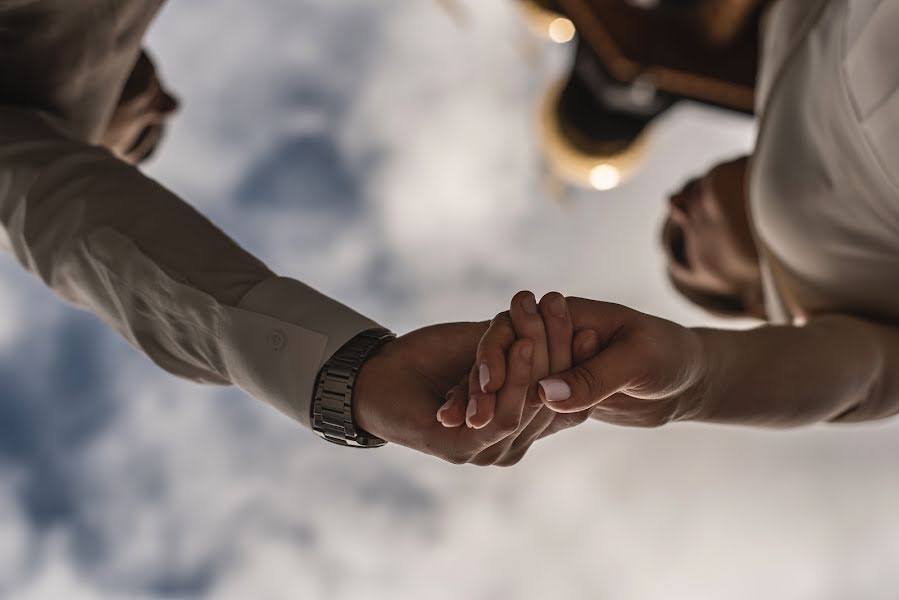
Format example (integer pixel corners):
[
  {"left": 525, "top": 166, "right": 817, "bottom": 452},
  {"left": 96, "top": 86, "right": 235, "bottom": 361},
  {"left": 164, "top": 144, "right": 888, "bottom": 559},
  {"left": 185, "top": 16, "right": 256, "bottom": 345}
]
[{"left": 0, "top": 0, "right": 899, "bottom": 600}]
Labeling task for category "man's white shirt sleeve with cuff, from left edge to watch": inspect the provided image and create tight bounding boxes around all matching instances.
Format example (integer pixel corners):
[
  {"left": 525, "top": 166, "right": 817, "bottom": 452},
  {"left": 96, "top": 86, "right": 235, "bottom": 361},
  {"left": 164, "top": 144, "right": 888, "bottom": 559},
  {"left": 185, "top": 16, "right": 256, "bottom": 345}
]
[{"left": 0, "top": 108, "right": 378, "bottom": 427}]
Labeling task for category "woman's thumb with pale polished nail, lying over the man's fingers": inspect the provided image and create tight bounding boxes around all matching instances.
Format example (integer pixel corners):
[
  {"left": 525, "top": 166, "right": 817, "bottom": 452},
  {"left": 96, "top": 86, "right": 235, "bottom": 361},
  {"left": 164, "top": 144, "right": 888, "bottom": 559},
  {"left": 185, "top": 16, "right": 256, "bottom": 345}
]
[{"left": 539, "top": 344, "right": 640, "bottom": 413}]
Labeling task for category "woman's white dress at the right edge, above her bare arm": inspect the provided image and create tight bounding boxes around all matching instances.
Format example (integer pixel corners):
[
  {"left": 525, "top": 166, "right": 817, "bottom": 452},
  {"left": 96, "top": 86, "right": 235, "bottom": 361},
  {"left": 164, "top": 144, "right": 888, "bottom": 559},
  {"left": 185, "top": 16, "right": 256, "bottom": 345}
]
[{"left": 749, "top": 0, "right": 899, "bottom": 321}]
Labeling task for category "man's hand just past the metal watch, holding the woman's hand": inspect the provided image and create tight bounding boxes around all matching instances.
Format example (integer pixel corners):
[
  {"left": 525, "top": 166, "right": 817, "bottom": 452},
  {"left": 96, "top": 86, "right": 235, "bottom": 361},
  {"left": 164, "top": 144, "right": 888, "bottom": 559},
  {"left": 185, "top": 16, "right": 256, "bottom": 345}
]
[{"left": 354, "top": 293, "right": 597, "bottom": 466}]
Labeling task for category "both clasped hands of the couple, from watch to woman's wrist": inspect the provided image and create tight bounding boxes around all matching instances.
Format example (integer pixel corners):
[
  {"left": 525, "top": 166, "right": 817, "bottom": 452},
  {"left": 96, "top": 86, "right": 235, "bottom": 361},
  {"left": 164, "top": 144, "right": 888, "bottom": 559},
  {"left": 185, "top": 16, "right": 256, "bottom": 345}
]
[{"left": 354, "top": 292, "right": 706, "bottom": 466}]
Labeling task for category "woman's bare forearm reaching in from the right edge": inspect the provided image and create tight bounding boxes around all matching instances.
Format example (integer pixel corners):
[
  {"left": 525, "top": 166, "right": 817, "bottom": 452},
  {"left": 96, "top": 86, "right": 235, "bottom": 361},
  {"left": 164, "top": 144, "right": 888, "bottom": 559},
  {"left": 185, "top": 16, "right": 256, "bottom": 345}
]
[{"left": 688, "top": 316, "right": 899, "bottom": 427}]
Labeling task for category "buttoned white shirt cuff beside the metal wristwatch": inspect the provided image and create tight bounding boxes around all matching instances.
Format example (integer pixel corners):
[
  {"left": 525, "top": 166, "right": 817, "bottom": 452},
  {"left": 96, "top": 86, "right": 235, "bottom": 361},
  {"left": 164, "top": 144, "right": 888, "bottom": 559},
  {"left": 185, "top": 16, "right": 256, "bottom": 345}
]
[{"left": 221, "top": 277, "right": 381, "bottom": 429}]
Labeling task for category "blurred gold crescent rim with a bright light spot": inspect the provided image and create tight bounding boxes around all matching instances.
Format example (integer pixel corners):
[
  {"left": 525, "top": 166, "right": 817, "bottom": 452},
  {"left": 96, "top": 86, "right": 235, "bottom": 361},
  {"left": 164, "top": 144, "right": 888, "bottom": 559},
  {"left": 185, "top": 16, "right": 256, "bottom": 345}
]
[{"left": 538, "top": 83, "right": 652, "bottom": 191}]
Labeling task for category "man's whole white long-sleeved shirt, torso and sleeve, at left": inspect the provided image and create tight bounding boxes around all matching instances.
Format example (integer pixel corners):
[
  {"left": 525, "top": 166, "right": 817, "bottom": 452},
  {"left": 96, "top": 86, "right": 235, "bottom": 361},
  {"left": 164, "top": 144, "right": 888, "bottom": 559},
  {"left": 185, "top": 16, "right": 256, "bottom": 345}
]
[{"left": 0, "top": 0, "right": 377, "bottom": 426}]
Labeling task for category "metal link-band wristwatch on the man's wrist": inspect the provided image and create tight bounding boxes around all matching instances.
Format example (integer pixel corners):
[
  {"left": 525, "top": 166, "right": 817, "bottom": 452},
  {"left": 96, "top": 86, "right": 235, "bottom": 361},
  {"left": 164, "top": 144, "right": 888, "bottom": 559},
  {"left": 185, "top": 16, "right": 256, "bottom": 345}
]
[{"left": 312, "top": 329, "right": 396, "bottom": 448}]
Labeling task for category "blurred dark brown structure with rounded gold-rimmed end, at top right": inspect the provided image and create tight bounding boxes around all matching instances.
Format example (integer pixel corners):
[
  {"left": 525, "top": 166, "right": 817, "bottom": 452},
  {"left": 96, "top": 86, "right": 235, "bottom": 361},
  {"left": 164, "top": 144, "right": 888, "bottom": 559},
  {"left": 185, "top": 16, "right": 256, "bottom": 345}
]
[{"left": 520, "top": 0, "right": 770, "bottom": 190}]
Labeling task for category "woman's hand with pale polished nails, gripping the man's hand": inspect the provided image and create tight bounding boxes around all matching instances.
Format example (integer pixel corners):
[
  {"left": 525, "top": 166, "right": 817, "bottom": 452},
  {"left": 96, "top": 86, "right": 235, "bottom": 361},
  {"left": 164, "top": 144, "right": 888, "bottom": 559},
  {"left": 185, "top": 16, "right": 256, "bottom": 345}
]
[{"left": 458, "top": 294, "right": 707, "bottom": 438}]
